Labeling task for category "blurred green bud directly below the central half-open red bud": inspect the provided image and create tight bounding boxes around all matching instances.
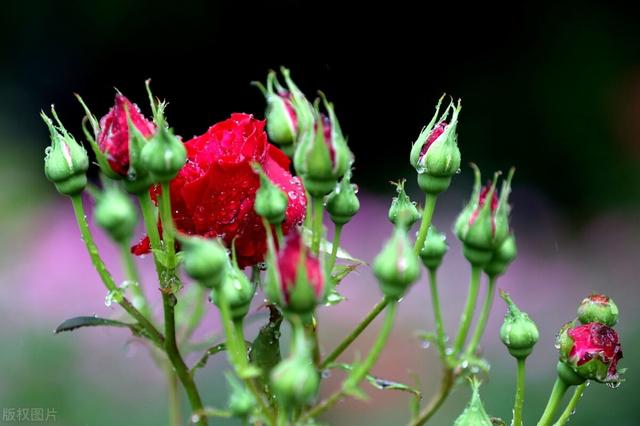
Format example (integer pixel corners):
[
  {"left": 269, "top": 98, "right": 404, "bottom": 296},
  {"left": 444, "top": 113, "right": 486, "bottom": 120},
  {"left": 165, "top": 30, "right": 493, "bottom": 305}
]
[{"left": 271, "top": 327, "right": 320, "bottom": 410}]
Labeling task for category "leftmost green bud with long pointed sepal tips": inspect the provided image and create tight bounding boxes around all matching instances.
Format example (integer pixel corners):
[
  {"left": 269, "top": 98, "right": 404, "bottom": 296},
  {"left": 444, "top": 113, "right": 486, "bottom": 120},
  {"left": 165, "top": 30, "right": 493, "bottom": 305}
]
[{"left": 40, "top": 105, "right": 89, "bottom": 196}]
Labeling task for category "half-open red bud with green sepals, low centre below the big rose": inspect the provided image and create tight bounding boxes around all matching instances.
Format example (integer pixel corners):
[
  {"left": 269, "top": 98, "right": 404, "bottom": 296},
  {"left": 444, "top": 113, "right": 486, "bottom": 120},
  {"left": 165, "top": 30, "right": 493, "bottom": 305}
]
[{"left": 266, "top": 229, "right": 329, "bottom": 315}]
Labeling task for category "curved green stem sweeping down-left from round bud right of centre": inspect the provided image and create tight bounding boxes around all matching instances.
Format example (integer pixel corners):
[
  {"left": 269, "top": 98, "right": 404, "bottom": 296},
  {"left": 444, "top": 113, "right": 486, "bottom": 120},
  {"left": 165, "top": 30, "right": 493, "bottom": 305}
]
[{"left": 300, "top": 301, "right": 398, "bottom": 423}]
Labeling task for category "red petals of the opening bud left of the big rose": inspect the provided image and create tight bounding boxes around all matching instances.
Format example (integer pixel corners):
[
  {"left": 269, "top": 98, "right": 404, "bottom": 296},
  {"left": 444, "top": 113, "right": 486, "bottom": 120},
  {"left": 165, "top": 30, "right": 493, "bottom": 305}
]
[{"left": 98, "top": 93, "right": 155, "bottom": 176}]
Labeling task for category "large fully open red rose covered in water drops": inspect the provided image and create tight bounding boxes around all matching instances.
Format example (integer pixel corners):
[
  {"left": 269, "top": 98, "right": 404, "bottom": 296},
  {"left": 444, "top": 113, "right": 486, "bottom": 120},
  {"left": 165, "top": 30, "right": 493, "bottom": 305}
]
[{"left": 133, "top": 113, "right": 306, "bottom": 267}]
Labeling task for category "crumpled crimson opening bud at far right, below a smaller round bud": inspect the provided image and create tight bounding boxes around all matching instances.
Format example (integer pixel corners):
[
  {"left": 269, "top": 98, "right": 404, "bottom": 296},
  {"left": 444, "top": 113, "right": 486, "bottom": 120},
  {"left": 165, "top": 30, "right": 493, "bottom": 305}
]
[{"left": 558, "top": 322, "right": 622, "bottom": 384}]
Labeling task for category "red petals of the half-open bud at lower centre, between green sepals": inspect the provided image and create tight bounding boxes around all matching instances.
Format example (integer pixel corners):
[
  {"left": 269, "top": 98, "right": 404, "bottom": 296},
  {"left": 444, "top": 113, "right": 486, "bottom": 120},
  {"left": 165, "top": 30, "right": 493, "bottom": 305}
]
[{"left": 277, "top": 230, "right": 324, "bottom": 303}]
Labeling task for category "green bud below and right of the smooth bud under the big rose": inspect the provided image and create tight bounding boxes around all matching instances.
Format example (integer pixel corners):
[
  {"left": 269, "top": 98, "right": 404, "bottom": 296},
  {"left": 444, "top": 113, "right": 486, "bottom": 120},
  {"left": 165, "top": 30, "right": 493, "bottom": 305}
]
[{"left": 211, "top": 262, "right": 256, "bottom": 321}]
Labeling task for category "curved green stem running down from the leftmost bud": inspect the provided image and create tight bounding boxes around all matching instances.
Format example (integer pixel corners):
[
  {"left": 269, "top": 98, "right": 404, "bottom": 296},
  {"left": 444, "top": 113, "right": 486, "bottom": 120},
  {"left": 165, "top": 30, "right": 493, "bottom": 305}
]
[{"left": 71, "top": 195, "right": 164, "bottom": 346}]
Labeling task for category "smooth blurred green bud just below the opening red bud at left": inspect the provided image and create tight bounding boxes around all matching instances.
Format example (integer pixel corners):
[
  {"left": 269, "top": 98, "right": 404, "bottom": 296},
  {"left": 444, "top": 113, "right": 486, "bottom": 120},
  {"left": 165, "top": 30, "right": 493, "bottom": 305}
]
[{"left": 94, "top": 187, "right": 138, "bottom": 245}]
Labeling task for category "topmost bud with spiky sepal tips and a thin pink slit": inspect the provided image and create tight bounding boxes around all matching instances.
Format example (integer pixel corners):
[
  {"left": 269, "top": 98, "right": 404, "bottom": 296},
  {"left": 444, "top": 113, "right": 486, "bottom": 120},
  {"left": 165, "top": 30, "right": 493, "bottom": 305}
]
[{"left": 253, "top": 68, "right": 302, "bottom": 151}]
